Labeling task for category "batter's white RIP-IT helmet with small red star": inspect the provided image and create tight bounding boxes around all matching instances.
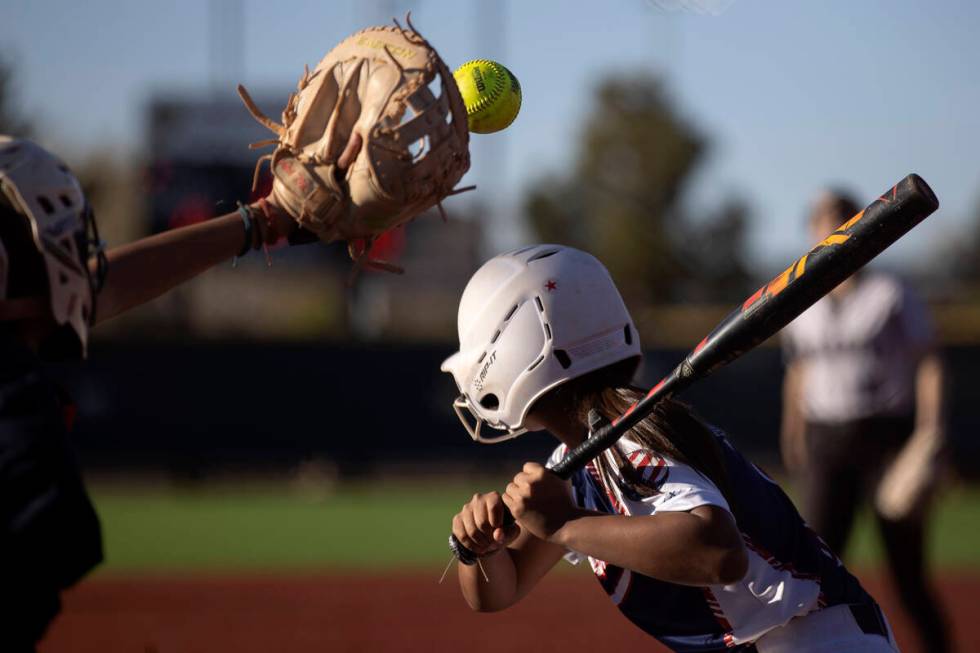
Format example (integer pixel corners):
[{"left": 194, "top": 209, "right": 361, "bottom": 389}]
[{"left": 441, "top": 245, "right": 640, "bottom": 443}]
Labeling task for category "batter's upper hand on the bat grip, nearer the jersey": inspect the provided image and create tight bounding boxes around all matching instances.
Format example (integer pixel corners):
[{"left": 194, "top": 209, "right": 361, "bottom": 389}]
[{"left": 504, "top": 463, "right": 577, "bottom": 541}]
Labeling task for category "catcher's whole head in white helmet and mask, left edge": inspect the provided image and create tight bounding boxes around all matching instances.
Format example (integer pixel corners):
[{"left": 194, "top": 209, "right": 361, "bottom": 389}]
[{"left": 0, "top": 135, "right": 107, "bottom": 357}]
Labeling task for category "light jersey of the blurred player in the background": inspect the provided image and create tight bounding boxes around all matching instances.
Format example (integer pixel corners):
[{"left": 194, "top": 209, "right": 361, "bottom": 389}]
[{"left": 783, "top": 273, "right": 933, "bottom": 424}]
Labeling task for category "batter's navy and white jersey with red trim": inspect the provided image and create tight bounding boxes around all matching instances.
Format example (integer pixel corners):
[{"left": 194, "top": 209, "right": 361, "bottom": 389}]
[{"left": 551, "top": 431, "right": 874, "bottom": 652}]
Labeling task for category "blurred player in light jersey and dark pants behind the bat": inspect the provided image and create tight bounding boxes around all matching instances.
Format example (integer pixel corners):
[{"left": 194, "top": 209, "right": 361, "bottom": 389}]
[{"left": 781, "top": 191, "right": 948, "bottom": 653}]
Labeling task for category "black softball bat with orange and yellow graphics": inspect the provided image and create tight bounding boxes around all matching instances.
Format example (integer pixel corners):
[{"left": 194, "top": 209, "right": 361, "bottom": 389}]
[{"left": 449, "top": 174, "right": 939, "bottom": 564}]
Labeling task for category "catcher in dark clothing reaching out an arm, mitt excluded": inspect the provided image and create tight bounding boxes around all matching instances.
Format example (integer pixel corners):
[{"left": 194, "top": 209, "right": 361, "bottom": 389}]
[{"left": 0, "top": 136, "right": 306, "bottom": 653}]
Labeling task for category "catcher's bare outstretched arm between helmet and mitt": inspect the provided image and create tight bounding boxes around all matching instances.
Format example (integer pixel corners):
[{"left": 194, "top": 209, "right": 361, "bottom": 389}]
[{"left": 96, "top": 202, "right": 296, "bottom": 323}]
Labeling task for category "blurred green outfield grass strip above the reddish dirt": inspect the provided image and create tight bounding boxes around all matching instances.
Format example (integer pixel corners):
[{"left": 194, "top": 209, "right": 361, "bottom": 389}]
[{"left": 93, "top": 482, "right": 980, "bottom": 573}]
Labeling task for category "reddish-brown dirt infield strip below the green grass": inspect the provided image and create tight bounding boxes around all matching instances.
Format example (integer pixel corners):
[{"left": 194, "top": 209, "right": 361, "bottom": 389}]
[{"left": 40, "top": 572, "right": 980, "bottom": 653}]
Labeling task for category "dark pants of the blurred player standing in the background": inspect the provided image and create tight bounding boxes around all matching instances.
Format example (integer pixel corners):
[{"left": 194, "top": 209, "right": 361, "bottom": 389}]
[{"left": 803, "top": 417, "right": 949, "bottom": 653}]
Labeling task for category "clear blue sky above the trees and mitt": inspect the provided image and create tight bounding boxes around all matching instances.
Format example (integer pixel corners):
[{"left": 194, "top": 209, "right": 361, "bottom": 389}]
[{"left": 0, "top": 0, "right": 980, "bottom": 271}]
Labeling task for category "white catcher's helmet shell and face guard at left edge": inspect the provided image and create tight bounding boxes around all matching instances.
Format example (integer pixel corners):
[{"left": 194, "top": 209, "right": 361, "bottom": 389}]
[{"left": 0, "top": 135, "right": 105, "bottom": 355}]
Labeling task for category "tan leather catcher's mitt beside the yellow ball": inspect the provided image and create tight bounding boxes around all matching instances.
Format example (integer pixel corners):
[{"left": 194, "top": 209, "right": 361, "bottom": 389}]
[{"left": 238, "top": 17, "right": 470, "bottom": 269}]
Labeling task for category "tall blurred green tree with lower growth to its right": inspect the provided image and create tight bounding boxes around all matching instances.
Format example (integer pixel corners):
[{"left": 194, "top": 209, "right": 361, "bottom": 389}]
[{"left": 525, "top": 76, "right": 749, "bottom": 302}]
